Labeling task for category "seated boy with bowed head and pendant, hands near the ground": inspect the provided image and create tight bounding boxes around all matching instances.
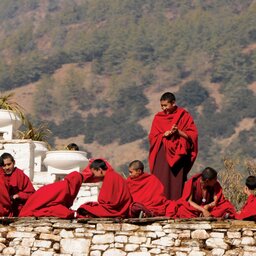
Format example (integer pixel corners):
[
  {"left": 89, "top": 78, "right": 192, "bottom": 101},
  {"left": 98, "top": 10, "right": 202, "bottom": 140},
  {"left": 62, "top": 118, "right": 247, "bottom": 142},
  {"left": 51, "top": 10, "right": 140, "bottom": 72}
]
[{"left": 176, "top": 167, "right": 235, "bottom": 218}]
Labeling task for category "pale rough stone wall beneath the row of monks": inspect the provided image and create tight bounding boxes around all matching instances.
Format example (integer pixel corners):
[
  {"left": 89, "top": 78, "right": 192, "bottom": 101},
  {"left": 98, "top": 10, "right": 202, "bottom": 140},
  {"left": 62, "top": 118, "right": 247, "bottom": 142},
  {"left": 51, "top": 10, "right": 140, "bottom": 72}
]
[{"left": 0, "top": 218, "right": 256, "bottom": 256}]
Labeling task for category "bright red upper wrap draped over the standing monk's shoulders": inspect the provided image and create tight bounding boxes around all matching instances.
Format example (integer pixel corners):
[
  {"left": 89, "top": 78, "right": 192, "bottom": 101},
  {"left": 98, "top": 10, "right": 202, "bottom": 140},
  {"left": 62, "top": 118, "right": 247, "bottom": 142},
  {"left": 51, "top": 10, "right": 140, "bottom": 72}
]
[{"left": 149, "top": 107, "right": 198, "bottom": 172}]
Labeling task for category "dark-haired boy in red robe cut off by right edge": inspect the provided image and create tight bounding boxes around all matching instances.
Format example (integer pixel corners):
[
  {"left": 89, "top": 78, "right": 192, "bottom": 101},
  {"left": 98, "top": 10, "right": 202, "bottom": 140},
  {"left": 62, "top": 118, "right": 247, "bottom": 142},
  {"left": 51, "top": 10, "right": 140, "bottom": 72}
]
[{"left": 235, "top": 176, "right": 256, "bottom": 221}]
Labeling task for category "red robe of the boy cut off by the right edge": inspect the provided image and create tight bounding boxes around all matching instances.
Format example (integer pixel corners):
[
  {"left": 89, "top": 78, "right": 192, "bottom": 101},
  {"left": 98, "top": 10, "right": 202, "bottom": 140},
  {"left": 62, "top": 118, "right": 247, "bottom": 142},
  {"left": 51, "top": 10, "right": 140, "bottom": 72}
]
[{"left": 235, "top": 195, "right": 256, "bottom": 221}]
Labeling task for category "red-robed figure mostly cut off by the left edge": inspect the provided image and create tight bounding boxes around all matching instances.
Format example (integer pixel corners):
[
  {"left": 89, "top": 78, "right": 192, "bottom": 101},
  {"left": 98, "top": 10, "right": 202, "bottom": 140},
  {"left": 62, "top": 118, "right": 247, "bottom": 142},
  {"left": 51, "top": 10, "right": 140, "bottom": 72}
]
[{"left": 0, "top": 157, "right": 11, "bottom": 217}]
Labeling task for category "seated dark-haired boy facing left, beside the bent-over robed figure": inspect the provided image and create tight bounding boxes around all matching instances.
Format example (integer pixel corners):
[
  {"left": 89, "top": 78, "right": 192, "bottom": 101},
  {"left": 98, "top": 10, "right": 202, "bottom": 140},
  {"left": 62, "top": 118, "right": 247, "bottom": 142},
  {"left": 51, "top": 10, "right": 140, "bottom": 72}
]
[{"left": 77, "top": 159, "right": 132, "bottom": 218}]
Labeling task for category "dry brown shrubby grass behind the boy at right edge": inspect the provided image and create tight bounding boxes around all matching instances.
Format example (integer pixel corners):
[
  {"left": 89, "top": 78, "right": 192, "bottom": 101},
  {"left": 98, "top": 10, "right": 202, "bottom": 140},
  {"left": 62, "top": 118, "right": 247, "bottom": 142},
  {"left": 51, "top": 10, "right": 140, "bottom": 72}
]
[{"left": 218, "top": 159, "right": 256, "bottom": 210}]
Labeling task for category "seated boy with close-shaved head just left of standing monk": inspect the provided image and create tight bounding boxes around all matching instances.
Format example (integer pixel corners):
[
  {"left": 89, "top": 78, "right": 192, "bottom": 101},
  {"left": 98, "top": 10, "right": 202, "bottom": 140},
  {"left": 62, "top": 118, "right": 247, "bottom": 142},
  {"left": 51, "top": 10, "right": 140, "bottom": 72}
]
[{"left": 127, "top": 160, "right": 176, "bottom": 217}]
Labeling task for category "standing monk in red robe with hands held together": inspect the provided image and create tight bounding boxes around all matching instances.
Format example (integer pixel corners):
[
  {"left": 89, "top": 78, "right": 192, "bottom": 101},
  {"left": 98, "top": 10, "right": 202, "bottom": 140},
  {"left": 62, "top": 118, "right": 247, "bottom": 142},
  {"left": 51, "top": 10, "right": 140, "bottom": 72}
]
[{"left": 149, "top": 92, "right": 198, "bottom": 200}]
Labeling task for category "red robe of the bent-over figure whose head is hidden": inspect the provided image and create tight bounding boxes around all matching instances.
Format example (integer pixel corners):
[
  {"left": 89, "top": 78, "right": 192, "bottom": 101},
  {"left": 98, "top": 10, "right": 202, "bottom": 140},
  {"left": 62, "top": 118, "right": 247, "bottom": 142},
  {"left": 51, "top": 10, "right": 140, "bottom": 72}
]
[{"left": 19, "top": 171, "right": 83, "bottom": 219}]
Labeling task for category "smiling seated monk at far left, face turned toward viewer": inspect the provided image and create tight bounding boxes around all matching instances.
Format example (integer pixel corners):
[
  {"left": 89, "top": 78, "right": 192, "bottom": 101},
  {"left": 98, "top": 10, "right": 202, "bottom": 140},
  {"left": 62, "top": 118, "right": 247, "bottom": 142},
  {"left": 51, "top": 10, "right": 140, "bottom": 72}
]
[{"left": 1, "top": 153, "right": 35, "bottom": 217}]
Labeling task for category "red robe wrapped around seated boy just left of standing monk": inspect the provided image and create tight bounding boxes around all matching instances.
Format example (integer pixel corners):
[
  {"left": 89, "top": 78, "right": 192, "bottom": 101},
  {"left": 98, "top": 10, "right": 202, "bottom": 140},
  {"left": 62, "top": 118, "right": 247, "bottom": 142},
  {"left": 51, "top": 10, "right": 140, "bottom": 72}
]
[{"left": 127, "top": 173, "right": 175, "bottom": 217}]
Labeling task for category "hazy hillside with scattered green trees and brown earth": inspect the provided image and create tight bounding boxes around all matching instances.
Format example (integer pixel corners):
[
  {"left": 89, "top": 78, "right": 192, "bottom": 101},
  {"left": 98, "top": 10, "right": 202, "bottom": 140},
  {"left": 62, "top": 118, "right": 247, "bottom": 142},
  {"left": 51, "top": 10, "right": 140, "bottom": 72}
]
[{"left": 0, "top": 0, "right": 256, "bottom": 174}]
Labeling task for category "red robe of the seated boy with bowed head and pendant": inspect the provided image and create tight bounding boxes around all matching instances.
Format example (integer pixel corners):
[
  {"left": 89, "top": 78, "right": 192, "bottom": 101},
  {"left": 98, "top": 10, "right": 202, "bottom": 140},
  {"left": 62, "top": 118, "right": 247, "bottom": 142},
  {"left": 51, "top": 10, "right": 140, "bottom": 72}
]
[{"left": 176, "top": 174, "right": 235, "bottom": 218}]
